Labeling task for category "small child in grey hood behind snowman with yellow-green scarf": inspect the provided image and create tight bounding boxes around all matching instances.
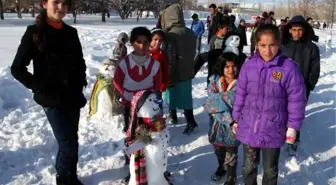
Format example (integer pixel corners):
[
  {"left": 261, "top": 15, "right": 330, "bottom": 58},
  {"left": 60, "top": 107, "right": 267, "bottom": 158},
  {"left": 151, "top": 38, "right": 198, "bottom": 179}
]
[{"left": 112, "top": 32, "right": 128, "bottom": 62}]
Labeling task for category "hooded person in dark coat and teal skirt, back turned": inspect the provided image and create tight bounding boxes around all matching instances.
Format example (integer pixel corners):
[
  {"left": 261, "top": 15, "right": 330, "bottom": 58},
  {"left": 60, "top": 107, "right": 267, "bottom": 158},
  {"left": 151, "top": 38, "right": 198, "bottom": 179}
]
[{"left": 162, "top": 3, "right": 198, "bottom": 134}]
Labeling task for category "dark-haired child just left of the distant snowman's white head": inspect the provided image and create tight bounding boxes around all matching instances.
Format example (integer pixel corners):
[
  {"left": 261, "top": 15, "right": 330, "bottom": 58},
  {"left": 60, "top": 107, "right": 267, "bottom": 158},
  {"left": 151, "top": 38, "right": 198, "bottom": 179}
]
[{"left": 209, "top": 20, "right": 229, "bottom": 50}]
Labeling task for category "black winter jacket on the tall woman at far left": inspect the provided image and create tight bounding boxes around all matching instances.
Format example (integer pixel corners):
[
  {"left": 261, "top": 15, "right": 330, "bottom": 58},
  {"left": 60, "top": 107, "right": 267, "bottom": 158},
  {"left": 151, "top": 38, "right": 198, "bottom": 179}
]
[{"left": 11, "top": 23, "right": 87, "bottom": 108}]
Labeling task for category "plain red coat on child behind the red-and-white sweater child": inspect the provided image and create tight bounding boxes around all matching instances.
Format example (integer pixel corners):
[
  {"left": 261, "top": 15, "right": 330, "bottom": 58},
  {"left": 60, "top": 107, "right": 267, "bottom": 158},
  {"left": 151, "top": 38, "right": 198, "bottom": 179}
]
[{"left": 148, "top": 50, "right": 168, "bottom": 92}]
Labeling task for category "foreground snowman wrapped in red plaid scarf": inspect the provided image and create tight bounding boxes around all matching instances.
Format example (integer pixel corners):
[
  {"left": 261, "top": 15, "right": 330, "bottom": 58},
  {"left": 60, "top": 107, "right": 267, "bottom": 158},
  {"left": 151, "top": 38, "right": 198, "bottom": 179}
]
[{"left": 125, "top": 90, "right": 171, "bottom": 185}]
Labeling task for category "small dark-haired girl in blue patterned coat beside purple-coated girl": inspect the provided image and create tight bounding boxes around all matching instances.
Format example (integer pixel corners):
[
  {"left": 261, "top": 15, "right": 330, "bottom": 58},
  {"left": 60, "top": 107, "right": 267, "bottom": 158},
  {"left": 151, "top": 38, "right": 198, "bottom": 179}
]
[{"left": 205, "top": 52, "right": 240, "bottom": 185}]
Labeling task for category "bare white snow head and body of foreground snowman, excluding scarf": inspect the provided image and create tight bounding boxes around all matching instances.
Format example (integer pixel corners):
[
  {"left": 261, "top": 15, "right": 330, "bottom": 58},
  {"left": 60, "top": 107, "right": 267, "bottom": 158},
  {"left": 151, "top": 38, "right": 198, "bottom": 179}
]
[{"left": 129, "top": 93, "right": 170, "bottom": 185}]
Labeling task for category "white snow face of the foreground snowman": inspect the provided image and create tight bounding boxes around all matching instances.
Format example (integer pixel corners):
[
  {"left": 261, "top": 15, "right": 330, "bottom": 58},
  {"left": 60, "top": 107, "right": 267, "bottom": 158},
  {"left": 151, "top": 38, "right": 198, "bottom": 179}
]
[{"left": 138, "top": 93, "right": 161, "bottom": 118}]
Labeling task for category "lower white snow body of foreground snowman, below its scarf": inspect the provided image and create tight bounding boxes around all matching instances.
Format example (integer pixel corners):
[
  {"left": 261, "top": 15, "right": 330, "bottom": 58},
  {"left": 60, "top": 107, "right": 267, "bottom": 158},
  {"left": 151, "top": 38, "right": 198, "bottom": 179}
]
[{"left": 129, "top": 128, "right": 169, "bottom": 185}]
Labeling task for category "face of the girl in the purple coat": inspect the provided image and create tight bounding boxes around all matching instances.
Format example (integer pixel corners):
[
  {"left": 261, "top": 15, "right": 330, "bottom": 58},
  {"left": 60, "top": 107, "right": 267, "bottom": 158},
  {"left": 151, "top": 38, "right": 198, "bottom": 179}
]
[{"left": 257, "top": 33, "right": 279, "bottom": 62}]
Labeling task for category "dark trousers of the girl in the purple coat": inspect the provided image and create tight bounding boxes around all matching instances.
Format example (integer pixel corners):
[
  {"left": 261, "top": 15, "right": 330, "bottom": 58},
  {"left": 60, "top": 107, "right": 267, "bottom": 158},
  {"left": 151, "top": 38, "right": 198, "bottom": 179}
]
[{"left": 243, "top": 145, "right": 280, "bottom": 185}]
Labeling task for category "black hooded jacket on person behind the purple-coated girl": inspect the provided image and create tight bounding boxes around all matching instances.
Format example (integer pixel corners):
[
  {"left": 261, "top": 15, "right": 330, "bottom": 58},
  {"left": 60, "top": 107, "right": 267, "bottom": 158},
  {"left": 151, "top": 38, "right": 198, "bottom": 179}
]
[{"left": 281, "top": 16, "right": 320, "bottom": 93}]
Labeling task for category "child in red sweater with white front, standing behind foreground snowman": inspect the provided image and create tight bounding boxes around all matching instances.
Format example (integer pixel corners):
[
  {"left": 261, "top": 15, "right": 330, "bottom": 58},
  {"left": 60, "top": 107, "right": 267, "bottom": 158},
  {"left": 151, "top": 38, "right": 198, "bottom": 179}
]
[{"left": 113, "top": 27, "right": 162, "bottom": 184}]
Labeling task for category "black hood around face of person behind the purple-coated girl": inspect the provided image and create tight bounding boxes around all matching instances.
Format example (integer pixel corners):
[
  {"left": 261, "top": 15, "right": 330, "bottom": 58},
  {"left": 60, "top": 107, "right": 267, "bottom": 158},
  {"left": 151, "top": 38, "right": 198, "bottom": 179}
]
[{"left": 281, "top": 15, "right": 315, "bottom": 44}]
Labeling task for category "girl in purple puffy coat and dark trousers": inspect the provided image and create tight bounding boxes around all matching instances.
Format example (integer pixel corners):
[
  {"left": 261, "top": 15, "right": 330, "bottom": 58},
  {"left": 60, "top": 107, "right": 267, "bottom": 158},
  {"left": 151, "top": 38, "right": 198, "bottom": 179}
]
[{"left": 232, "top": 24, "right": 306, "bottom": 185}]
